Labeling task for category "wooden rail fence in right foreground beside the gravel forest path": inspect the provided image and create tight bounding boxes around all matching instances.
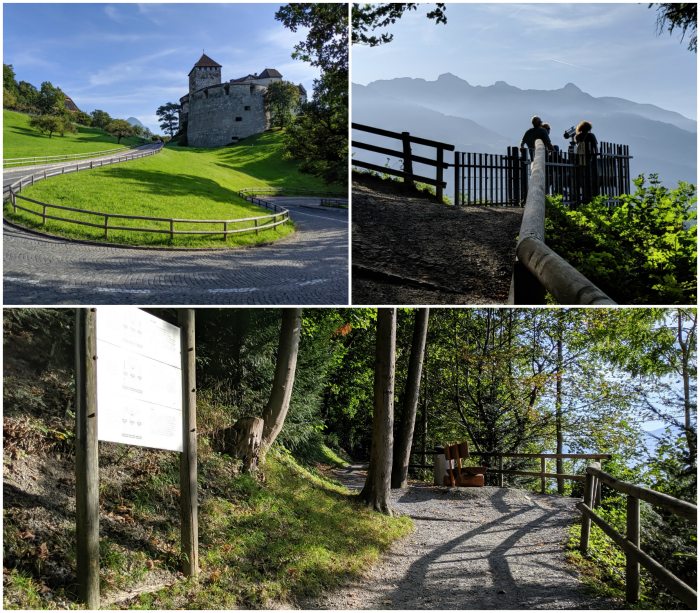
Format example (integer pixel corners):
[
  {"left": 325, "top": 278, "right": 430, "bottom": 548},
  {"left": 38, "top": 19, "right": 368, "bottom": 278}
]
[{"left": 576, "top": 462, "right": 698, "bottom": 610}]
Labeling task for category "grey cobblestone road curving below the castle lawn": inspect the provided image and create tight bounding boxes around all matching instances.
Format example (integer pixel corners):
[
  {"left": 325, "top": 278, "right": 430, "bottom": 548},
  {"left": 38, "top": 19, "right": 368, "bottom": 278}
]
[{"left": 3, "top": 198, "right": 348, "bottom": 305}]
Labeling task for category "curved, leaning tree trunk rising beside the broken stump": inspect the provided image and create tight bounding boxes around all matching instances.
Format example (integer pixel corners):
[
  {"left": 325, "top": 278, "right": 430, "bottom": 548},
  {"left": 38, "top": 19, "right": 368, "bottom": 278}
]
[{"left": 262, "top": 309, "right": 301, "bottom": 453}]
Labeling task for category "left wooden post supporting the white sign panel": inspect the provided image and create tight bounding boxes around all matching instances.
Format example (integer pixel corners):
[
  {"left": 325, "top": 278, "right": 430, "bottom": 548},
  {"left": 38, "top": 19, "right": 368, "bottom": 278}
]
[{"left": 75, "top": 309, "right": 100, "bottom": 609}]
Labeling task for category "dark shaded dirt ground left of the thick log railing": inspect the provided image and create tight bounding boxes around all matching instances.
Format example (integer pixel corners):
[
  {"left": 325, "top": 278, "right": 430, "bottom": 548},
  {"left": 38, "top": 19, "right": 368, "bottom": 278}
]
[{"left": 352, "top": 173, "right": 523, "bottom": 305}]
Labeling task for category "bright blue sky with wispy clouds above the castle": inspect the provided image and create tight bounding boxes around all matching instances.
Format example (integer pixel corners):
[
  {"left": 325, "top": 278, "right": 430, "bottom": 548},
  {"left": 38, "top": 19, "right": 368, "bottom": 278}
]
[{"left": 3, "top": 2, "right": 319, "bottom": 133}]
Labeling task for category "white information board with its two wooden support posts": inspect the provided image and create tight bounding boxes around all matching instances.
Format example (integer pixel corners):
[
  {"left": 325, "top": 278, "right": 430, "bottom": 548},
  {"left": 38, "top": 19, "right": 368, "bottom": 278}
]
[{"left": 75, "top": 307, "right": 199, "bottom": 609}]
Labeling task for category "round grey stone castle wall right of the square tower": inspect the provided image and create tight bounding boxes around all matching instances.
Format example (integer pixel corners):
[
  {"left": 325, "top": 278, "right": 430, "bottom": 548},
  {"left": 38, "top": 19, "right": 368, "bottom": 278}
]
[{"left": 187, "top": 83, "right": 270, "bottom": 147}]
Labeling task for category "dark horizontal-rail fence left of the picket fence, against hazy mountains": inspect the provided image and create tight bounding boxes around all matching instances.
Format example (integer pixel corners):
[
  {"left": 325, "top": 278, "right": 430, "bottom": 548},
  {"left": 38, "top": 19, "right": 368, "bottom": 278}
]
[{"left": 352, "top": 123, "right": 455, "bottom": 202}]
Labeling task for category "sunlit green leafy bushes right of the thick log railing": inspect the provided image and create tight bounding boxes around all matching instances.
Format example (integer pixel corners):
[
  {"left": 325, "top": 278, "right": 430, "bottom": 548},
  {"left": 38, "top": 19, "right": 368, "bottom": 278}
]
[{"left": 545, "top": 175, "right": 697, "bottom": 304}]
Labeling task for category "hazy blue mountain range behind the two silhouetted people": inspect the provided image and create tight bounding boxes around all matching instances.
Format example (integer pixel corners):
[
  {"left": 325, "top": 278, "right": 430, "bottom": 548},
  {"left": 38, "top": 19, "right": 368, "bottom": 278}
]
[{"left": 352, "top": 73, "right": 697, "bottom": 194}]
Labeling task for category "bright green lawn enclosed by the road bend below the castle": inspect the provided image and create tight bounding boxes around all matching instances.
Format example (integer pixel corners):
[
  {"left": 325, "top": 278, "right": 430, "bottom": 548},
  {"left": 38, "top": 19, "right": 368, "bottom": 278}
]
[{"left": 5, "top": 132, "right": 336, "bottom": 247}]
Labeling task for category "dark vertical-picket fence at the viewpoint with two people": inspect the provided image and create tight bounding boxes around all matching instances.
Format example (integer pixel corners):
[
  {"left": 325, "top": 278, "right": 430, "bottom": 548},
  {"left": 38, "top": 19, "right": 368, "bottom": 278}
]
[{"left": 450, "top": 143, "right": 631, "bottom": 206}]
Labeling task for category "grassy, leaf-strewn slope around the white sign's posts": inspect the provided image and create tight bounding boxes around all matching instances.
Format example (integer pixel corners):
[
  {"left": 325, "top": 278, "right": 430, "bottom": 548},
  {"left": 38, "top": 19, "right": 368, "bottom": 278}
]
[{"left": 3, "top": 315, "right": 412, "bottom": 609}]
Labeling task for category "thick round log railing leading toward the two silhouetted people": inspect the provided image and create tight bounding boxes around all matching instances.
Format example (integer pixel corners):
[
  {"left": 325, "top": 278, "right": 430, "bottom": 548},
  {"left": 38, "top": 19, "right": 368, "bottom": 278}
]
[{"left": 508, "top": 140, "right": 616, "bottom": 305}]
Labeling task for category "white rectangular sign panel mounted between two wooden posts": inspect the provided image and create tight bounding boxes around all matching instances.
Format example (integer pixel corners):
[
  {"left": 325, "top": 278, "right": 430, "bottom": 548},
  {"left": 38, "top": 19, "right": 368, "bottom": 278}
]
[{"left": 96, "top": 307, "right": 183, "bottom": 451}]
